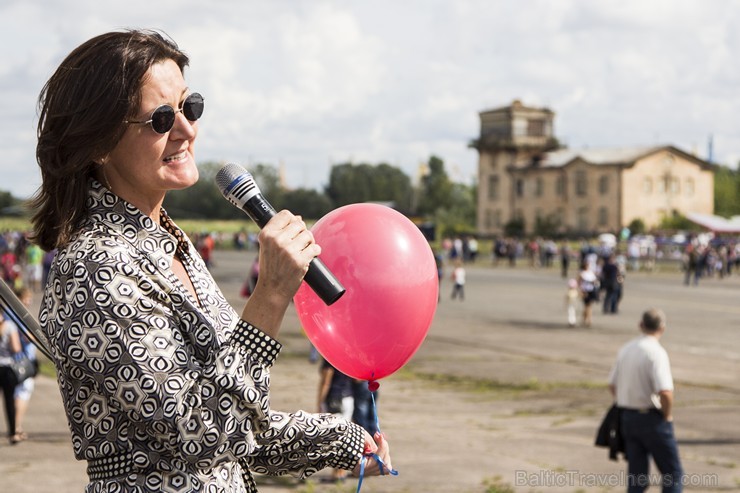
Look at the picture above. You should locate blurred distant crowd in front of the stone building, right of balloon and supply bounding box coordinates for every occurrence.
[435,235,740,327]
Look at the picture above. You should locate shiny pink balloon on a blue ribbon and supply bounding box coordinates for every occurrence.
[294,204,439,380]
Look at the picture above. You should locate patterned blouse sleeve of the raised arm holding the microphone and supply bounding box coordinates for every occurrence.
[41,246,286,469]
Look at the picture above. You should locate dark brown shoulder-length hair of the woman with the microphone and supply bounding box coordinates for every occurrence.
[30,29,189,251]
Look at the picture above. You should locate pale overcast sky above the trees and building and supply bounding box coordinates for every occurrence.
[0,0,740,197]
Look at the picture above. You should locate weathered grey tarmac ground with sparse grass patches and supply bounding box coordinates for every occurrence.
[0,252,740,493]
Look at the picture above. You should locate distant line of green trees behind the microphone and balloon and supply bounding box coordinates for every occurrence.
[0,156,476,233]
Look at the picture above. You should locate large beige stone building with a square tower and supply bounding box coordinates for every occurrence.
[471,101,714,236]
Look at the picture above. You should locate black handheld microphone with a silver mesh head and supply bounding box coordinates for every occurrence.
[216,164,346,306]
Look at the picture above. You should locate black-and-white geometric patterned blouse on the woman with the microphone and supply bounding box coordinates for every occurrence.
[39,180,364,493]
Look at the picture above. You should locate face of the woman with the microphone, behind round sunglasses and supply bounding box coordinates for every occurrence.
[102,60,198,215]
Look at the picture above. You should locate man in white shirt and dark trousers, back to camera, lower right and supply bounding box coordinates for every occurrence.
[609,309,683,493]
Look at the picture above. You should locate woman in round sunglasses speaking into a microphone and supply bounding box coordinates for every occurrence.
[34,31,390,492]
